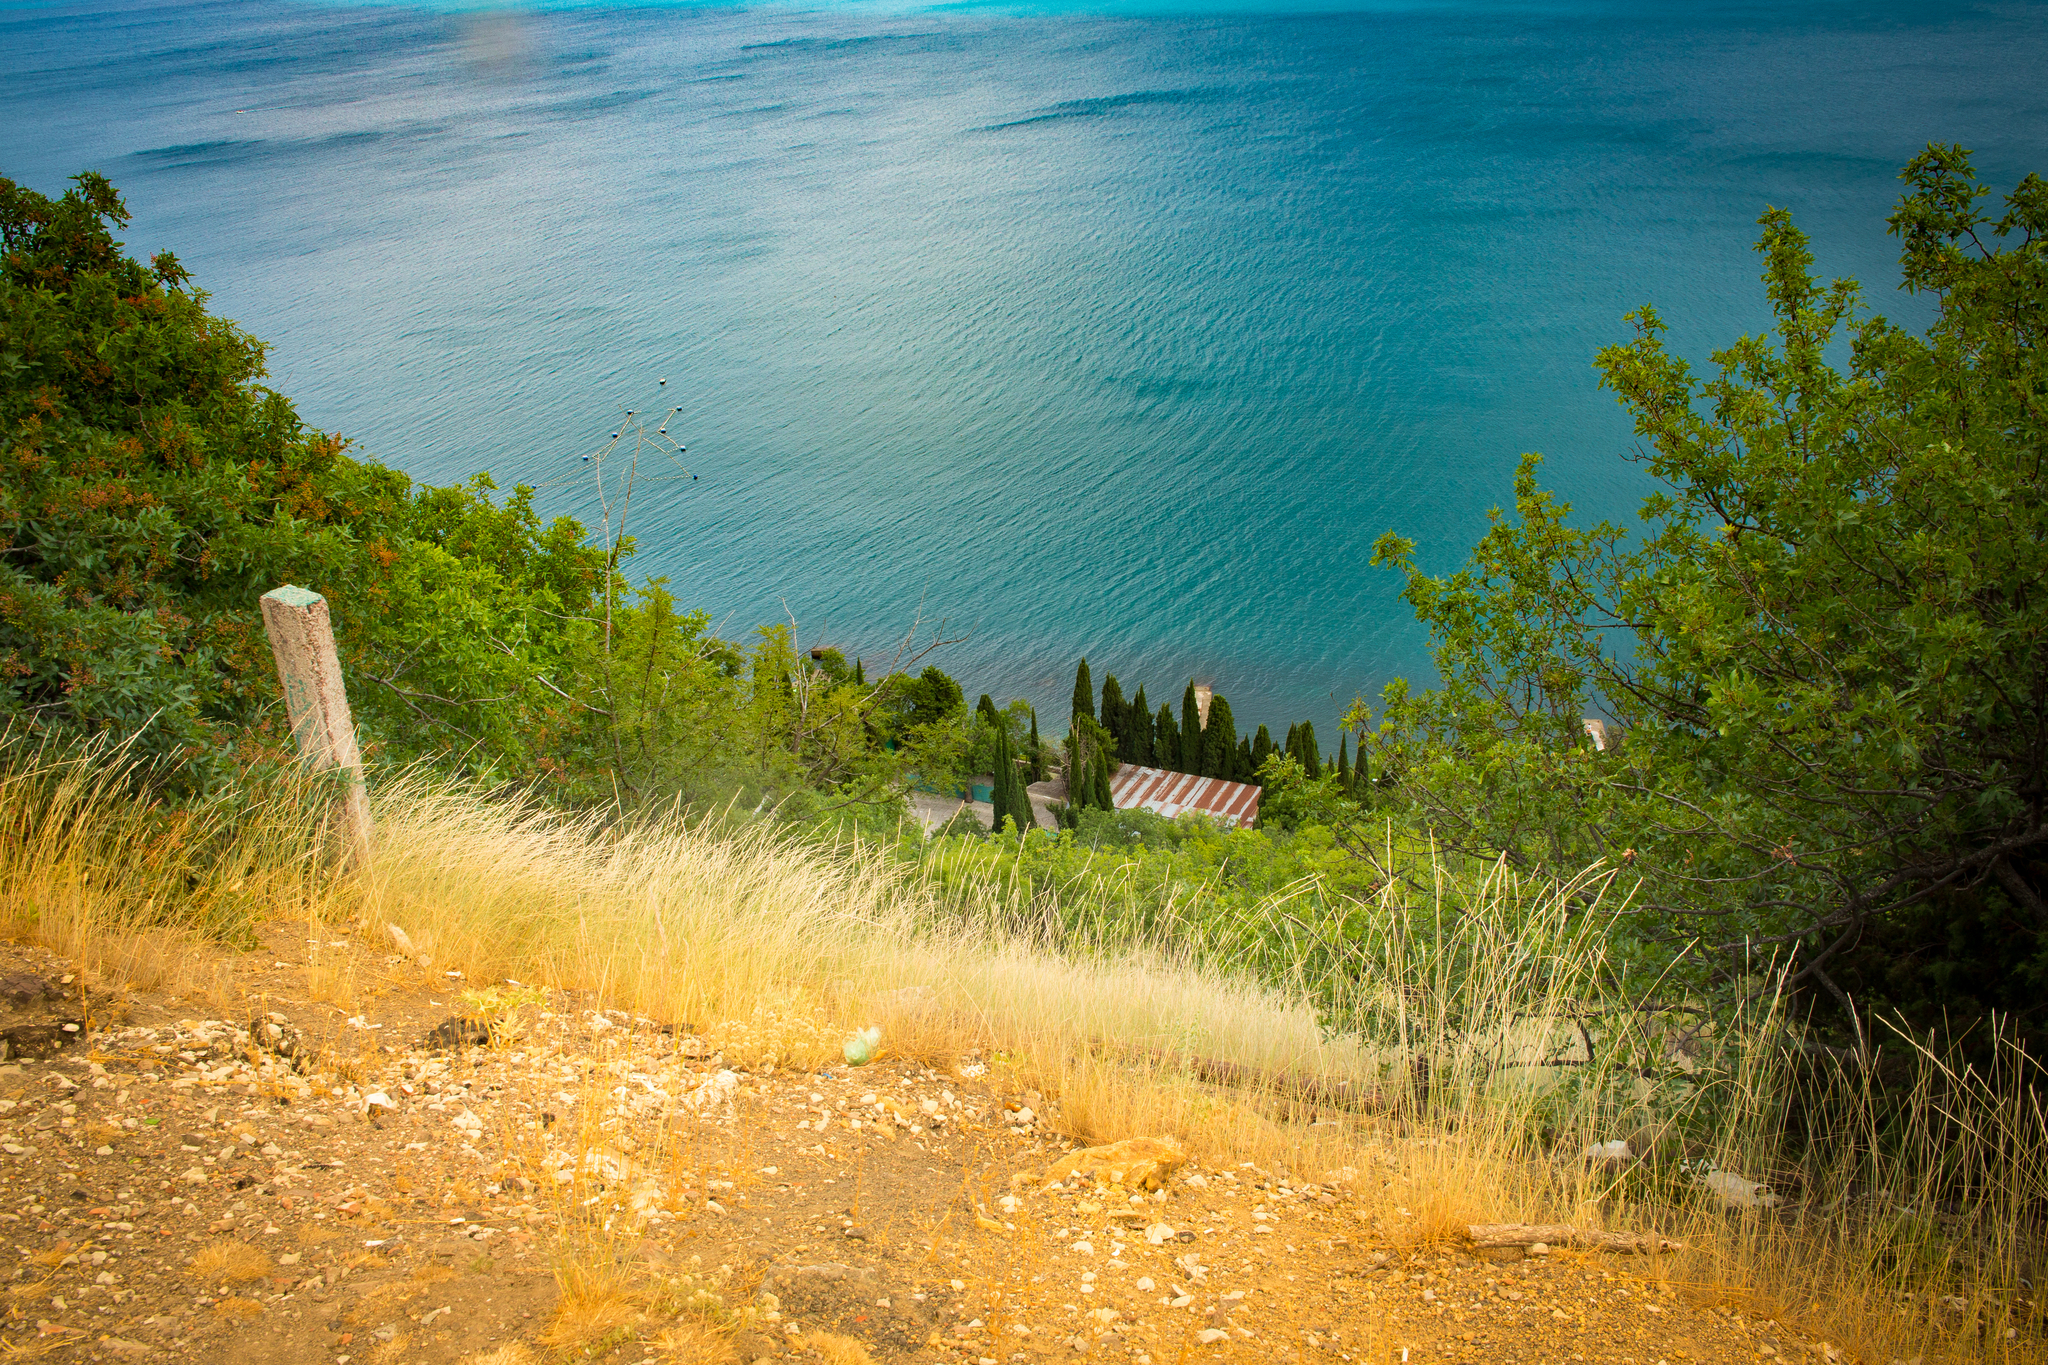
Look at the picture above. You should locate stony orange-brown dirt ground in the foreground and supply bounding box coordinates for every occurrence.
[0,927,1839,1365]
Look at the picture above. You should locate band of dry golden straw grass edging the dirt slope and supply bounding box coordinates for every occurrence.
[0,753,2048,1363]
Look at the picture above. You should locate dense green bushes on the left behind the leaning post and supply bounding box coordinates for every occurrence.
[0,174,608,784]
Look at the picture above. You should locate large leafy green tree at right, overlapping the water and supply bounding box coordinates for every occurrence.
[1358,145,2048,1038]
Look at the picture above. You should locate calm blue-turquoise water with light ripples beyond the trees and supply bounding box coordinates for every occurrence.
[0,0,2048,733]
